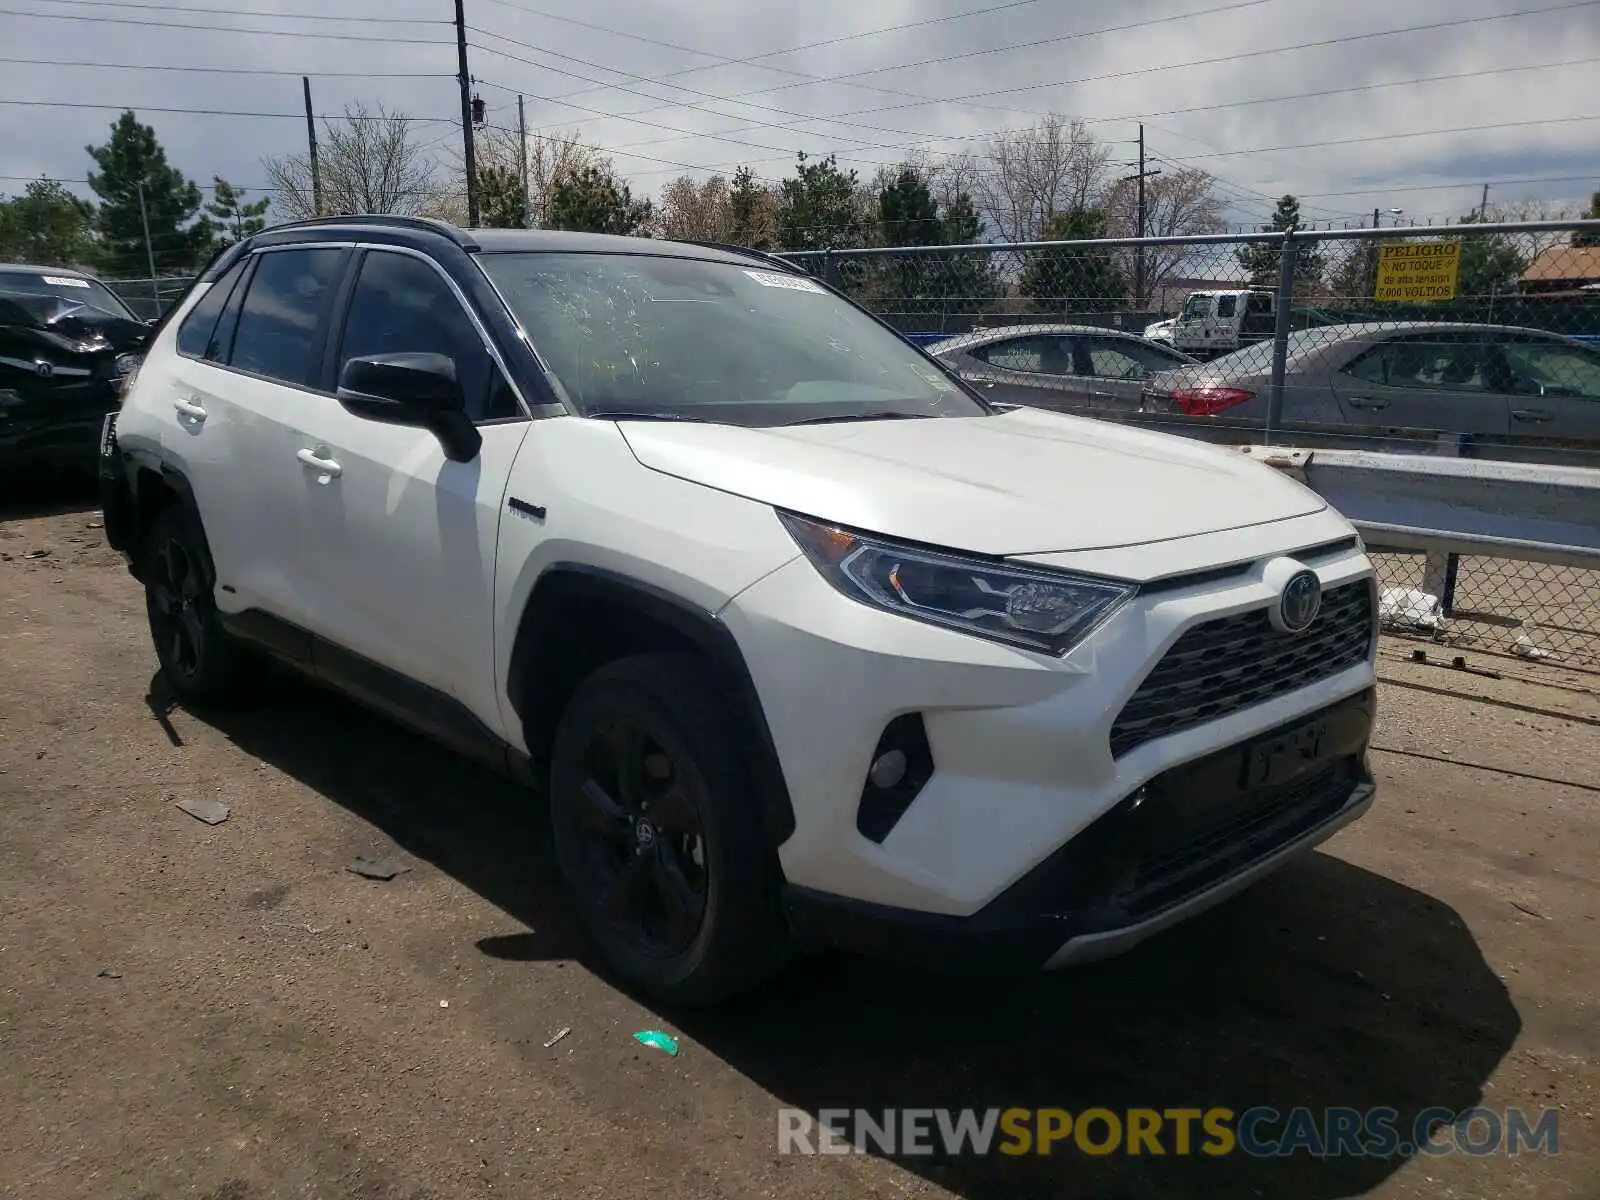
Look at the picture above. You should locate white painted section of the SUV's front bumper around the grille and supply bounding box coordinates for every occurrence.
[720,514,1376,918]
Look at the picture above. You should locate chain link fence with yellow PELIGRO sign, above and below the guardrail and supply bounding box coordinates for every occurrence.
[786,221,1600,669]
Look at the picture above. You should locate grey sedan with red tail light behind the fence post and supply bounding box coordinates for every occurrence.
[1142,322,1600,438]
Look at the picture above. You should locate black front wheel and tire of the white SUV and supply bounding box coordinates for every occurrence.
[550,654,789,1005]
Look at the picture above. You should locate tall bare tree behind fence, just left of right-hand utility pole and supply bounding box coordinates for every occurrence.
[973,115,1110,242]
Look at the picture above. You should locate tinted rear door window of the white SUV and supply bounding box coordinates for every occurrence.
[229,248,344,387]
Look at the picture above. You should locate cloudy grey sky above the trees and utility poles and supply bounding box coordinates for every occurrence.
[0,0,1600,230]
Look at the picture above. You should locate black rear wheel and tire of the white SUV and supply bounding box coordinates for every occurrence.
[141,504,261,707]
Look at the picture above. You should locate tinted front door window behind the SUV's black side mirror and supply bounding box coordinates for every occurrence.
[339,250,522,421]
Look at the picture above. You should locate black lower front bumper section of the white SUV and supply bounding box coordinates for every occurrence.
[786,691,1374,970]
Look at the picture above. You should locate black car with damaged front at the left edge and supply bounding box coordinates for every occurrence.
[0,264,150,475]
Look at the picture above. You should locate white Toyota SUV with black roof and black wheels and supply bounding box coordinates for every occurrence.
[101,218,1376,1002]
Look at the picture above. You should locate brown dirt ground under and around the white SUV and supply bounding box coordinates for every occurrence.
[0,492,1600,1200]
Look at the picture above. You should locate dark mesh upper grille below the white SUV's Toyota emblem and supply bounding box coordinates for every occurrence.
[1110,579,1373,758]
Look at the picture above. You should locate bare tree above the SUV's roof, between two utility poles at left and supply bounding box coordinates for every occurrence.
[262,102,438,219]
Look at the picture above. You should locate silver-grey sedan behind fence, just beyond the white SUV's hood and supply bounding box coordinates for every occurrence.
[926,325,1195,413]
